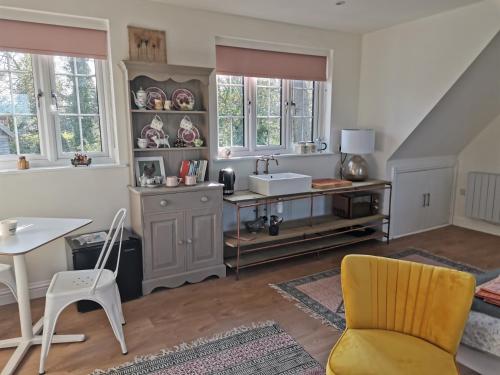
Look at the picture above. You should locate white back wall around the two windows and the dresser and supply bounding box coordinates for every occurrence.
[0,0,361,302]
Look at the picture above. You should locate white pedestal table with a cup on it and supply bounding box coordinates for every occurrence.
[0,217,92,375]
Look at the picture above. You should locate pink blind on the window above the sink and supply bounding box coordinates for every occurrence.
[216,45,326,81]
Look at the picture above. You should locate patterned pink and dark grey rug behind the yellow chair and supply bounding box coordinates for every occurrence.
[271,248,484,331]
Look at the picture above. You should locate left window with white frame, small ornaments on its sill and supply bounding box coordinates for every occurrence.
[0,52,111,168]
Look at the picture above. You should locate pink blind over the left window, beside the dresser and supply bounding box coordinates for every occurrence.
[0,19,108,59]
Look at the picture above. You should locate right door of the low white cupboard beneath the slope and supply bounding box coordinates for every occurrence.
[425,168,453,228]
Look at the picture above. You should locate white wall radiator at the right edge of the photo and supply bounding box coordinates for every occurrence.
[465,172,500,224]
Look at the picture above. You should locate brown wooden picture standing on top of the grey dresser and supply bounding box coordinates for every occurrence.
[128,26,167,63]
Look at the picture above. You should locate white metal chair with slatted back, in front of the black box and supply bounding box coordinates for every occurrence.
[39,208,127,374]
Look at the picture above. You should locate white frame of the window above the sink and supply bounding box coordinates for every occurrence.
[214,76,325,157]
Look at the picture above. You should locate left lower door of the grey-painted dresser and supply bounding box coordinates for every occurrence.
[144,212,186,278]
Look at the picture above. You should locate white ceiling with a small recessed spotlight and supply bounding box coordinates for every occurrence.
[151,0,480,33]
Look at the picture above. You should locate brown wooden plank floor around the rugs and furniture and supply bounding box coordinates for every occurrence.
[0,226,500,375]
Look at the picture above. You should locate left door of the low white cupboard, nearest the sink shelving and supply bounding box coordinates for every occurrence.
[391,171,427,236]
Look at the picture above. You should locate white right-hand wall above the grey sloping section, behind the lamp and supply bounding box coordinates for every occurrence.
[358,2,500,177]
